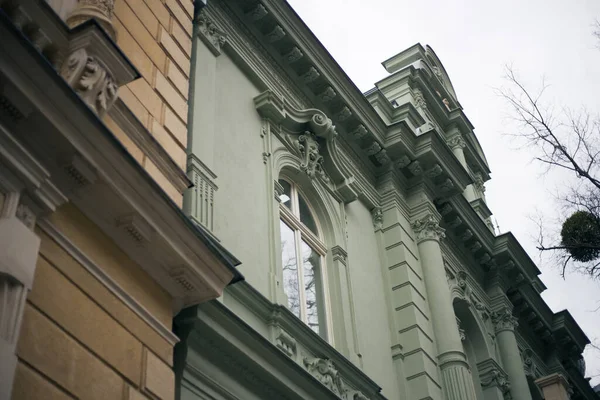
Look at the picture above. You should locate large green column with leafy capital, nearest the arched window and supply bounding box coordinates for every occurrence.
[412,214,476,400]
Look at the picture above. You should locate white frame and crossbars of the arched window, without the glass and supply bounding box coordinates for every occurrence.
[278,180,333,344]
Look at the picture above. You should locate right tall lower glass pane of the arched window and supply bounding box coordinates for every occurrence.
[302,241,321,333]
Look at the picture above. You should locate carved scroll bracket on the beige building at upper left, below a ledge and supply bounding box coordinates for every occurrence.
[61,49,118,116]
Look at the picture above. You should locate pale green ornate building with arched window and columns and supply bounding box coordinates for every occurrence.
[175,0,597,400]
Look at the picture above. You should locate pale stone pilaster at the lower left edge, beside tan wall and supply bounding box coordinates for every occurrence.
[0,192,40,400]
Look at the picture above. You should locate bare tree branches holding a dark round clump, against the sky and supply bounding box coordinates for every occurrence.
[498,65,600,278]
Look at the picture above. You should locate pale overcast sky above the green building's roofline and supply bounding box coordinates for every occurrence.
[289,0,600,383]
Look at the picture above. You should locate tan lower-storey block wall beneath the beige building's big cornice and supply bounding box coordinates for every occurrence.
[13,205,175,399]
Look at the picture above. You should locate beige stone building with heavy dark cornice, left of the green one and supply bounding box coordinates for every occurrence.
[0,0,241,400]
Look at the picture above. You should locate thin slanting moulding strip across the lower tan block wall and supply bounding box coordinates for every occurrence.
[38,219,179,346]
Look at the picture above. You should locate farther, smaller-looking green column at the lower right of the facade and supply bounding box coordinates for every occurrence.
[492,307,532,400]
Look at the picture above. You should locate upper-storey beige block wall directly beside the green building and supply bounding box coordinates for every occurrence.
[105,0,194,204]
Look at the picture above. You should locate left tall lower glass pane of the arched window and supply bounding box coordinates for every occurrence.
[279,221,300,318]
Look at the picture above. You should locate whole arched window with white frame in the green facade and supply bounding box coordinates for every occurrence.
[279,179,327,338]
